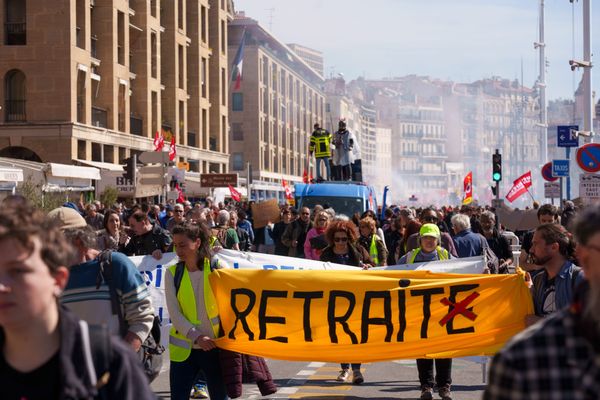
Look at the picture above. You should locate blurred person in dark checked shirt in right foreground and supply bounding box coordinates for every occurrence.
[483,205,600,400]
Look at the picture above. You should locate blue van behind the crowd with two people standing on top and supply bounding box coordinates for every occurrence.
[294,181,377,218]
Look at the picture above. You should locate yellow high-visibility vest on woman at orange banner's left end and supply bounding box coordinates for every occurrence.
[168,258,221,362]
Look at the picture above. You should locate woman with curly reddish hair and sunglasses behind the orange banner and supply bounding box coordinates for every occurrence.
[321,221,375,385]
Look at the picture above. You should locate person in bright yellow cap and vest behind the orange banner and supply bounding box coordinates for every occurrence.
[398,224,452,400]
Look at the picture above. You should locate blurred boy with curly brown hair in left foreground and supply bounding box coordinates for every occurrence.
[0,205,156,400]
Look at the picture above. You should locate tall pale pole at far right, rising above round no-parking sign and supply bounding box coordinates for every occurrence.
[583,0,594,141]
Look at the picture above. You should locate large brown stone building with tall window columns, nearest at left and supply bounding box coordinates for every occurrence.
[0,0,233,187]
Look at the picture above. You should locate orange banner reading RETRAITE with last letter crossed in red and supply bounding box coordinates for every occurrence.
[210,269,533,362]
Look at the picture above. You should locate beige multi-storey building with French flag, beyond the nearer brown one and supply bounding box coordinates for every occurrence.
[229,13,325,200]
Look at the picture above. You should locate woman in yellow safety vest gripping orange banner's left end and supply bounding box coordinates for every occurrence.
[165,223,228,400]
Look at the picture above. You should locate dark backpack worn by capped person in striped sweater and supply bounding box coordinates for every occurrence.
[96,250,165,382]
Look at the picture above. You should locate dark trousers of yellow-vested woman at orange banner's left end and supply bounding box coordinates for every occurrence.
[169,349,229,400]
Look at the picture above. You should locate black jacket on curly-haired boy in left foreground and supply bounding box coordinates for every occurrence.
[0,306,156,400]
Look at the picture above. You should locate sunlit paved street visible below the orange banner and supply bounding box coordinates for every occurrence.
[152,359,484,400]
